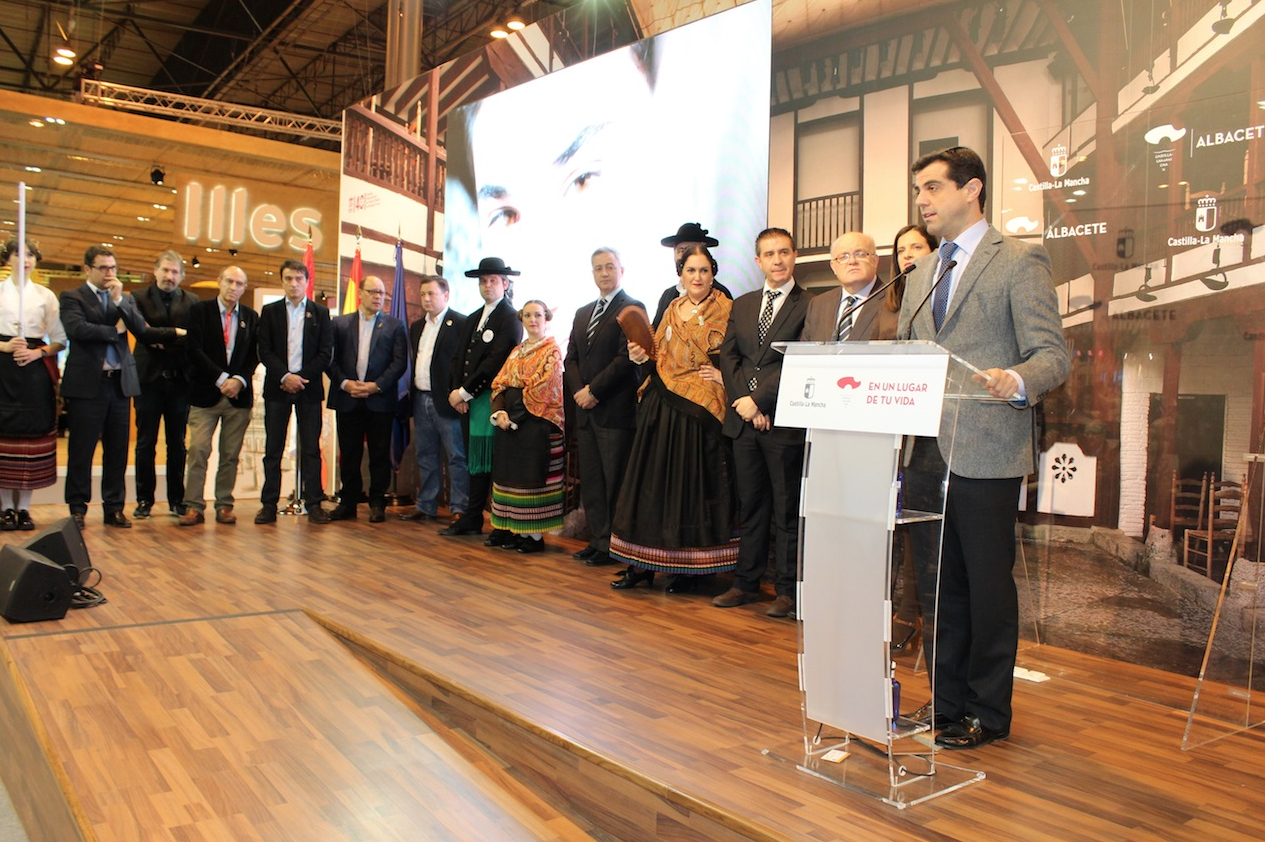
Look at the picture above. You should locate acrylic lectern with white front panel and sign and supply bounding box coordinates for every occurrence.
[765,341,999,808]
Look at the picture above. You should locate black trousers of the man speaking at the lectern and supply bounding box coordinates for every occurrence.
[906,439,1022,731]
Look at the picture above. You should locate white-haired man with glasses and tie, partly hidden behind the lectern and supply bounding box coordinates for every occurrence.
[799,231,899,343]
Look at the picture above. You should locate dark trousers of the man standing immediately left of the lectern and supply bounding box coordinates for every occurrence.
[734,424,803,599]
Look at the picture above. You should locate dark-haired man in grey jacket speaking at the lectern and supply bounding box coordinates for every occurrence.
[899,147,1070,748]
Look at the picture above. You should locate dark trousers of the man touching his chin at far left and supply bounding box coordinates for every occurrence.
[66,372,132,515]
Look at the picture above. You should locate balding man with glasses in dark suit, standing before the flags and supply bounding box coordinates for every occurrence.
[329,274,409,523]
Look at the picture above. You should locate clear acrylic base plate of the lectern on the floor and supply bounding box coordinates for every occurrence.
[760,738,984,810]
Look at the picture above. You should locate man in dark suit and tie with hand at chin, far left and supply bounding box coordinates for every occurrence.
[61,245,185,528]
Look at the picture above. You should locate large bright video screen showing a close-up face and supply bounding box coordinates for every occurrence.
[444,0,770,333]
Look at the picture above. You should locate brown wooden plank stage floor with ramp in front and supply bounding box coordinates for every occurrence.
[0,503,1265,842]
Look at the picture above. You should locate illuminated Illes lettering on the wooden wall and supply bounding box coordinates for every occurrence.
[183,181,323,252]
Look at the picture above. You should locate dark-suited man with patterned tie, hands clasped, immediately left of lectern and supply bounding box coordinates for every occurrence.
[712,228,808,617]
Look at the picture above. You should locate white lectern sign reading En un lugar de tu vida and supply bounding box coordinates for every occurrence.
[777,354,949,436]
